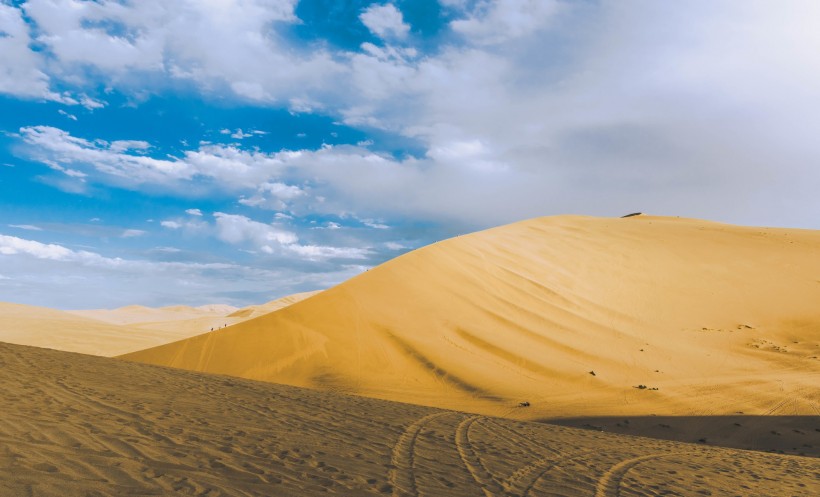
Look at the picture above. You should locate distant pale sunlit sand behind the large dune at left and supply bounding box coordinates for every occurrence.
[0,292,318,357]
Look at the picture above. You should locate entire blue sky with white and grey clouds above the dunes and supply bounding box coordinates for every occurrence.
[0,0,820,309]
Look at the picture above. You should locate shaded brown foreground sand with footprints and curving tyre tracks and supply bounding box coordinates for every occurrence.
[0,344,820,497]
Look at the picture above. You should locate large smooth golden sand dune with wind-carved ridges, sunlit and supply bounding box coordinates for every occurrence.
[120,216,820,446]
